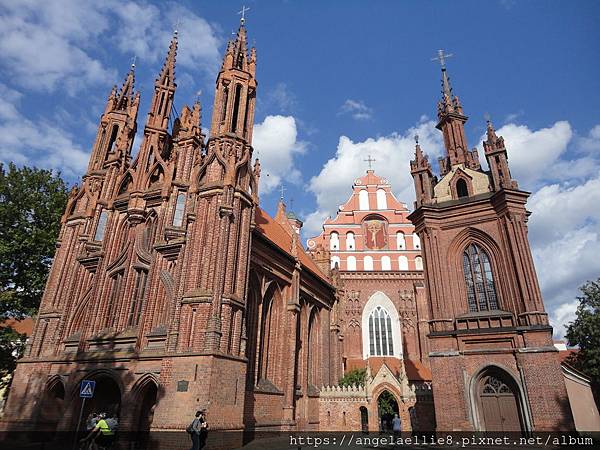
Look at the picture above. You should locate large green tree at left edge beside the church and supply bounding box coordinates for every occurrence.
[0,163,68,384]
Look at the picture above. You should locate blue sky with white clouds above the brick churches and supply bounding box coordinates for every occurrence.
[0,0,600,335]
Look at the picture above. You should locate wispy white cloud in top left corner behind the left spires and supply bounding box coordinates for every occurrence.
[0,0,219,94]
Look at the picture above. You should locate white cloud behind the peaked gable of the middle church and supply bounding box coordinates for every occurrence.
[304,118,442,236]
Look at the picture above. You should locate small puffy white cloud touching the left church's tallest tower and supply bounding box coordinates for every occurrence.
[252,116,306,194]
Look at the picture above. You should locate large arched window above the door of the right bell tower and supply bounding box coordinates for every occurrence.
[463,244,498,312]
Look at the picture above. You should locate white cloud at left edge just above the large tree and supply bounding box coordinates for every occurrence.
[0,83,89,178]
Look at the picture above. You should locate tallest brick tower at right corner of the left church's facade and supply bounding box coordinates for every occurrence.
[161,14,260,429]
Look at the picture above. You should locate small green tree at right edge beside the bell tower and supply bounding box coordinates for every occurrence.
[566,278,600,398]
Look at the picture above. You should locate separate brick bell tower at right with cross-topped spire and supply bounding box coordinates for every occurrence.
[409,51,572,432]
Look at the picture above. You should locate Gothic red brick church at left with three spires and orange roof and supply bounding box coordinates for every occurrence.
[3,24,341,442]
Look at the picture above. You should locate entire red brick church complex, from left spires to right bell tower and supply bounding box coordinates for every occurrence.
[3,16,573,442]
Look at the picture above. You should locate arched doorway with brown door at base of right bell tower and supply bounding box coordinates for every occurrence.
[474,367,525,432]
